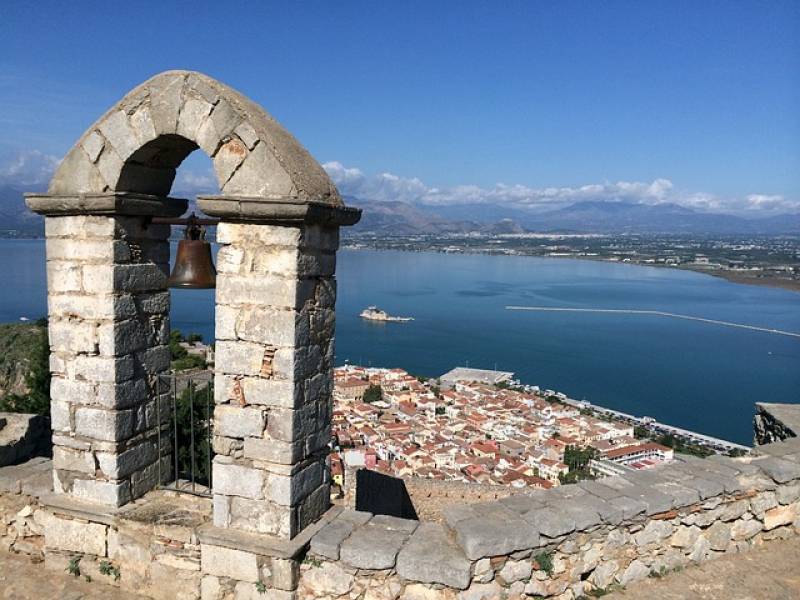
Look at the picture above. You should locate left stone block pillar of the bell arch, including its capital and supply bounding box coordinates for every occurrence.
[28,194,185,506]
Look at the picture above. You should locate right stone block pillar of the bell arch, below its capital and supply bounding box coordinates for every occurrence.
[213,223,339,538]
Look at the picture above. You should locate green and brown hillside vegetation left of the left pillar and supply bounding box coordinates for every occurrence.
[0,320,50,415]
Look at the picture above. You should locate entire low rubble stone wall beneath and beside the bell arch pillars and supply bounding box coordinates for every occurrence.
[0,438,800,600]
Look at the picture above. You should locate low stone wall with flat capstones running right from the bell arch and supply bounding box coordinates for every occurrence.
[298,440,800,600]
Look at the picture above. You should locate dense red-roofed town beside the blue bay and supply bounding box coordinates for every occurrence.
[331,365,674,489]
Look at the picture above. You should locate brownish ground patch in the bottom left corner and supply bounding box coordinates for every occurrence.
[0,552,145,600]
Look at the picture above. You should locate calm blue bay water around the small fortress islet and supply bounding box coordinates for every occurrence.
[0,240,800,443]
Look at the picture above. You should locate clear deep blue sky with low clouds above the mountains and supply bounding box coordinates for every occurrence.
[0,0,800,214]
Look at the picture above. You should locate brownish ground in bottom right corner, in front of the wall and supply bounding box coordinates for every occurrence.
[607,538,800,600]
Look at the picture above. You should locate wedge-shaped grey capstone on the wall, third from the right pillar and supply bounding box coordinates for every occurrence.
[396,523,471,590]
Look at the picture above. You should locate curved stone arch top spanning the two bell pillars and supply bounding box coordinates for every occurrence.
[48,71,343,207]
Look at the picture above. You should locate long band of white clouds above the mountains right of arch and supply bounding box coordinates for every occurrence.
[322,161,800,215]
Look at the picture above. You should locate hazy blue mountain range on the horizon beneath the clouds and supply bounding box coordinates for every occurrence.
[0,185,800,237]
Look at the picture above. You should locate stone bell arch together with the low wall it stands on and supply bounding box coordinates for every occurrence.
[0,71,800,600]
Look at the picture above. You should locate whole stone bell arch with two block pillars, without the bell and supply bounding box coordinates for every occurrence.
[27,71,360,539]
